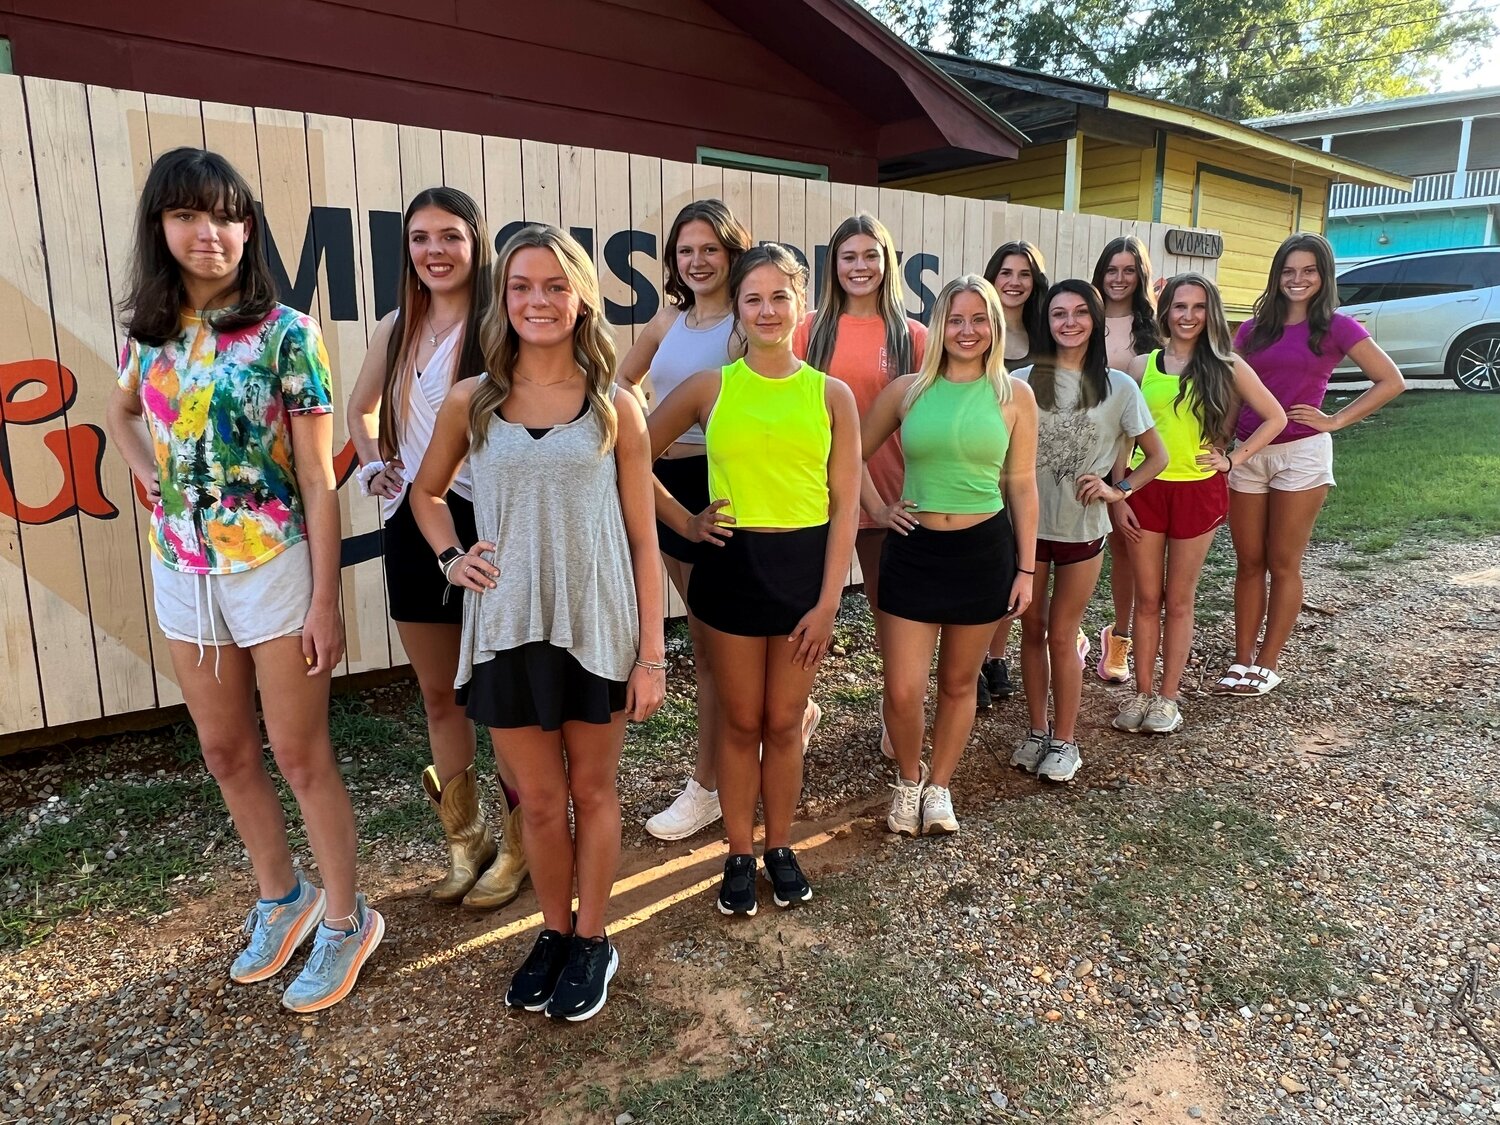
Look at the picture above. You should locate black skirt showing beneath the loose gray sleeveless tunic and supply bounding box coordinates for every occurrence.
[456,641,626,731]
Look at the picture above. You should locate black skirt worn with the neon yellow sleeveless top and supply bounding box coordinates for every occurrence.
[687,524,828,636]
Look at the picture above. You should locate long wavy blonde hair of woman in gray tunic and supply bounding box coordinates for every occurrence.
[470,224,620,456]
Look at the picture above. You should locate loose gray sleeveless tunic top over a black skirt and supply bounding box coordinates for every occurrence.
[455,408,639,687]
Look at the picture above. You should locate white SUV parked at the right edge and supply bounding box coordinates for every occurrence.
[1337,246,1500,392]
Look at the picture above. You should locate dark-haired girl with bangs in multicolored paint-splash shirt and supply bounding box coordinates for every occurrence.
[107,149,386,1013]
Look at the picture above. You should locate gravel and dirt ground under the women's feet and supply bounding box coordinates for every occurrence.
[0,540,1500,1125]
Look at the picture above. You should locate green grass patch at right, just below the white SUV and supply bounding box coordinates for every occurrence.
[1314,392,1500,554]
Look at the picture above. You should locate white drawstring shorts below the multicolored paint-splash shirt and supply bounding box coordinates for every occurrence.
[152,540,312,650]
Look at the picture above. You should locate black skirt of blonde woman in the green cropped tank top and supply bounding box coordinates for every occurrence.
[881,512,1016,626]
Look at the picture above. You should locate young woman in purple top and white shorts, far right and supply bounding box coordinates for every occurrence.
[1214,234,1406,696]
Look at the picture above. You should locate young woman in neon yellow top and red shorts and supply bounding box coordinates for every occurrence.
[1115,273,1287,735]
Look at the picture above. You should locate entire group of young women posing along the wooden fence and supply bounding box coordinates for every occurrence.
[108,149,1401,1020]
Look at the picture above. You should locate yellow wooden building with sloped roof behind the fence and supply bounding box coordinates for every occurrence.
[882,53,1410,320]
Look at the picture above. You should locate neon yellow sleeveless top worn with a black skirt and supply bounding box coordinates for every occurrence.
[704,359,834,528]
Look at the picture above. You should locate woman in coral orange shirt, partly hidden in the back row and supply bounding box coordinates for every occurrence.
[792,212,927,633]
